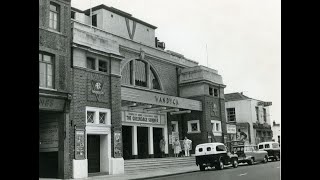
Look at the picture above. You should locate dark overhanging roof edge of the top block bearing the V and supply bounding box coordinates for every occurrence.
[83,4,157,29]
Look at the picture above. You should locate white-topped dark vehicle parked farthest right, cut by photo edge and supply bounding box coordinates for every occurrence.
[258,142,280,161]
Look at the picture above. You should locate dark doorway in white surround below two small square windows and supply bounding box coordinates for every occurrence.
[87,135,100,173]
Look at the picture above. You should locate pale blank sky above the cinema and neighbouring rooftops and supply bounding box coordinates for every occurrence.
[71,0,281,123]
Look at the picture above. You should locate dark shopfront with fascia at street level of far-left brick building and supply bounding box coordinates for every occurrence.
[39,93,69,178]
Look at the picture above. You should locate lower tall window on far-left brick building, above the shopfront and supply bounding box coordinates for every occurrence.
[39,53,54,89]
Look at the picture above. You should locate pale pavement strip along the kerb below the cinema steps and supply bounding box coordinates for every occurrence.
[39,165,199,180]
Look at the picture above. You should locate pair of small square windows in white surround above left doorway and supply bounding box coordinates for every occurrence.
[86,107,111,125]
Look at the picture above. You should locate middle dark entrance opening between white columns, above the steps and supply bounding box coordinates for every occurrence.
[137,127,149,159]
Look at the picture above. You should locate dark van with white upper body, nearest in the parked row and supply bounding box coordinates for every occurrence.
[195,143,238,171]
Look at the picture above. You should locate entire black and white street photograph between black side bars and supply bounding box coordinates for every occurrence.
[36,0,285,180]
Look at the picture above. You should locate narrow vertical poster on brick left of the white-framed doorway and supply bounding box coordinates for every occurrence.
[74,129,85,159]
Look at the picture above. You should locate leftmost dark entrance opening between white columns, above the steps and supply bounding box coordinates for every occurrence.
[122,126,132,159]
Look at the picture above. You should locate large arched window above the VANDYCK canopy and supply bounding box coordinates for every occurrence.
[121,59,161,90]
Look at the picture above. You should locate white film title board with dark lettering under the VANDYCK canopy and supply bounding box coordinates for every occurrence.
[125,111,160,124]
